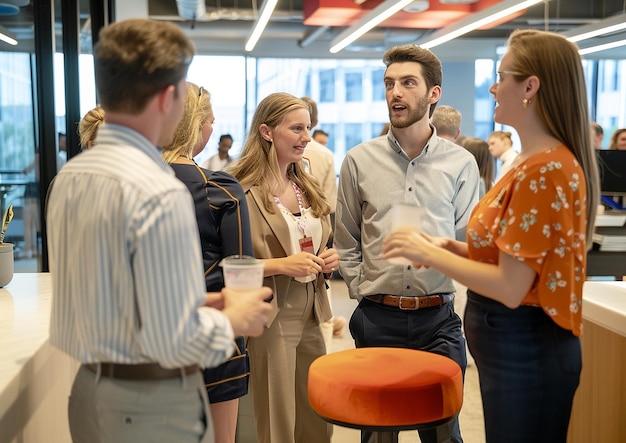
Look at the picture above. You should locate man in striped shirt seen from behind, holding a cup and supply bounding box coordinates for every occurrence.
[46,19,272,443]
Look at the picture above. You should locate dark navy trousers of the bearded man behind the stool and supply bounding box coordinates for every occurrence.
[350,299,467,443]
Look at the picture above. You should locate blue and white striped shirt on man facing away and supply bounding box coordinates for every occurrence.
[47,124,234,368]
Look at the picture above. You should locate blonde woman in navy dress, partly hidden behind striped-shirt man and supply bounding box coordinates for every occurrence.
[161,82,254,443]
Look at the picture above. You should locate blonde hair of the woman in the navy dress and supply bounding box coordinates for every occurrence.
[161,82,213,163]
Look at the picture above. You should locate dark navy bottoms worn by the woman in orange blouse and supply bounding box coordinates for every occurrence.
[464,291,582,443]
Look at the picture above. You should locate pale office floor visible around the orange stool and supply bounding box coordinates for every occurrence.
[331,279,485,443]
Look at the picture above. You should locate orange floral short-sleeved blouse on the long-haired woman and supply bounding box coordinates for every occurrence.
[467,146,587,336]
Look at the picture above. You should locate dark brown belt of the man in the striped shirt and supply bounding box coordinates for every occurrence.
[85,363,200,381]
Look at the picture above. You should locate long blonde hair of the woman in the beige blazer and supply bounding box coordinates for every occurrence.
[226,92,330,217]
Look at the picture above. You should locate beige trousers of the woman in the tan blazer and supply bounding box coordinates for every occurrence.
[248,280,332,443]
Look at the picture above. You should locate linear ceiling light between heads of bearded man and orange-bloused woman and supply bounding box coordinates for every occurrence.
[415,0,544,49]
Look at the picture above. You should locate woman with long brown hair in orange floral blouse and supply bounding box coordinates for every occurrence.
[384,30,599,443]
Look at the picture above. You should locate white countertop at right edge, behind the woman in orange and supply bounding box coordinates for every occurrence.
[583,281,626,337]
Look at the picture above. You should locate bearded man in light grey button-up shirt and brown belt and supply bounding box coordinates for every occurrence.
[334,45,480,443]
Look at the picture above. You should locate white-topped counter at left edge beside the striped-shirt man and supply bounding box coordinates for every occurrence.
[0,273,78,443]
